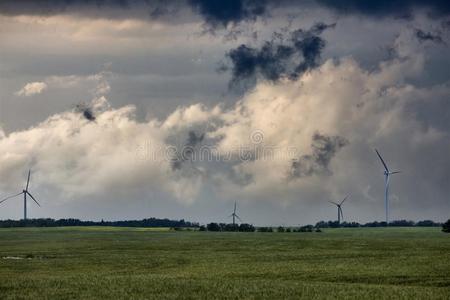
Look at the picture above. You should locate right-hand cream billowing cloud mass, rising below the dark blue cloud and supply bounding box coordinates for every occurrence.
[202,32,450,211]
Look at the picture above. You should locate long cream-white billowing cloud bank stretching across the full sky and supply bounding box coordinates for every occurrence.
[0,32,450,216]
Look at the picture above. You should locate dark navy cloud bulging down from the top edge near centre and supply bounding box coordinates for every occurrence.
[189,0,267,30]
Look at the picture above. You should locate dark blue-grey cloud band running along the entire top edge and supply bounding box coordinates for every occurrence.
[0,0,450,21]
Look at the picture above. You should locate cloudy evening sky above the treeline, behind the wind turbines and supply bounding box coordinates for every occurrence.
[0,0,450,225]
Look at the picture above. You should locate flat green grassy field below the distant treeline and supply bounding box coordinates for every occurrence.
[0,227,450,299]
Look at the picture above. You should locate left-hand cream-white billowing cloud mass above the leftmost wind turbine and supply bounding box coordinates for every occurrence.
[0,96,200,202]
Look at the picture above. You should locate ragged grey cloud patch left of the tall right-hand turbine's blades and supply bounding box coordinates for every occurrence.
[290,133,349,179]
